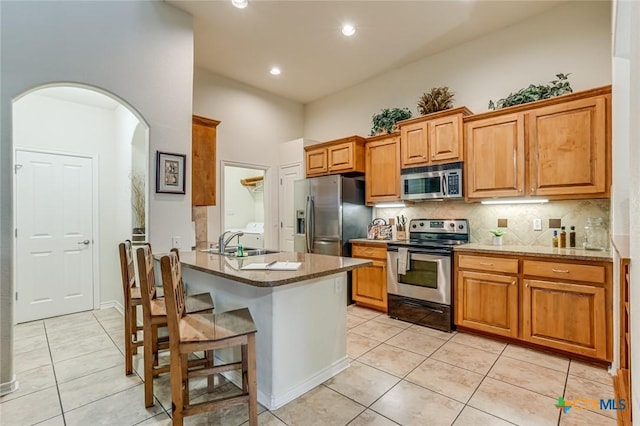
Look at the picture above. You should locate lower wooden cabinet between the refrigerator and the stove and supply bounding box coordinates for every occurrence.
[351,243,387,312]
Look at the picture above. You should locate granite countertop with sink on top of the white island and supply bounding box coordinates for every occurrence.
[164,251,373,287]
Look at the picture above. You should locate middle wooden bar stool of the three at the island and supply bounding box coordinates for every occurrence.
[136,244,214,407]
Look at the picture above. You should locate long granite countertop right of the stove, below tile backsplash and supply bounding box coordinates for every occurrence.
[454,243,613,262]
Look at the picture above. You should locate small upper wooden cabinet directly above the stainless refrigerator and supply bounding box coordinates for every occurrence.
[304,136,365,177]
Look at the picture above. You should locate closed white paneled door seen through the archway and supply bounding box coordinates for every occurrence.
[15,150,94,322]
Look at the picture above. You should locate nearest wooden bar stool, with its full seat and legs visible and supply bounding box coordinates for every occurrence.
[160,253,258,426]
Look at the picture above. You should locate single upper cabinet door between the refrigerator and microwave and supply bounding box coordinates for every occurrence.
[365,136,400,204]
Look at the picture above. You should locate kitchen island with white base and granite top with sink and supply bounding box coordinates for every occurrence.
[171,252,371,410]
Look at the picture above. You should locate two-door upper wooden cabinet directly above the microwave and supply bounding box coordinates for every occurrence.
[397,107,471,168]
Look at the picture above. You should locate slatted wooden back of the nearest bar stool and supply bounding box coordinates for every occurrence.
[160,252,185,340]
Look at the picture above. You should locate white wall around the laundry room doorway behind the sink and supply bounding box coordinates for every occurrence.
[193,68,303,247]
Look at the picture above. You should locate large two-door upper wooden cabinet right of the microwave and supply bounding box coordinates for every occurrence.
[464,86,611,200]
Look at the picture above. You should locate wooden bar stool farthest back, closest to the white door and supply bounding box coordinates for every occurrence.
[118,240,143,375]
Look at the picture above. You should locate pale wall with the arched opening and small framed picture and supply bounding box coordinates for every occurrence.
[0,1,193,392]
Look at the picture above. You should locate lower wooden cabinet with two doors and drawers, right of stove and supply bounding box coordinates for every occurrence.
[454,252,613,361]
